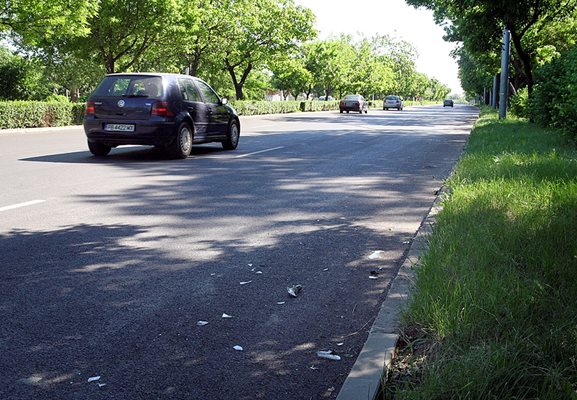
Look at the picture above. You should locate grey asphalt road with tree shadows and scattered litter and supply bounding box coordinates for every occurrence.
[0,106,477,400]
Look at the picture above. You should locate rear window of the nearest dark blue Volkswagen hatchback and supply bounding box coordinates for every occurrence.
[94,75,162,98]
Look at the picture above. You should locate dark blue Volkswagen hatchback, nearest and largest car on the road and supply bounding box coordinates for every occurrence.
[84,73,240,158]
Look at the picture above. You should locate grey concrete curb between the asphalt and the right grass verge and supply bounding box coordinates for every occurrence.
[337,196,442,400]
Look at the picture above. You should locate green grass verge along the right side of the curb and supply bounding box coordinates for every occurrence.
[385,110,577,400]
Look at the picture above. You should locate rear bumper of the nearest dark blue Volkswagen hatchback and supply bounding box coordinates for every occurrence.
[84,119,176,147]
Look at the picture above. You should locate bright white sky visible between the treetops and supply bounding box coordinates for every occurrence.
[295,0,463,94]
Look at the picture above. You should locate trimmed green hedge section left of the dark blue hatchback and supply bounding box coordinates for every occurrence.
[0,101,85,129]
